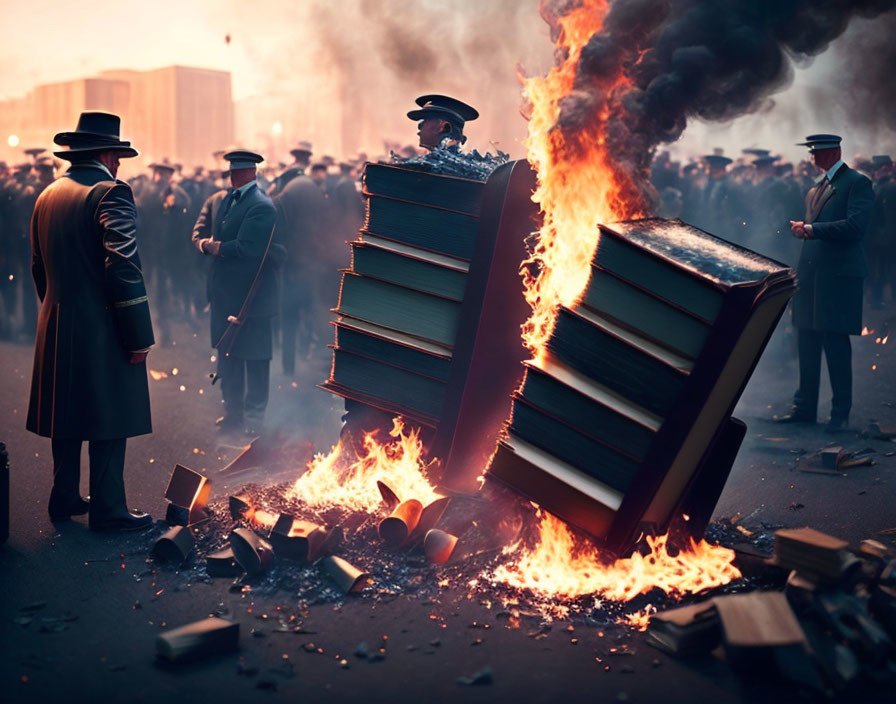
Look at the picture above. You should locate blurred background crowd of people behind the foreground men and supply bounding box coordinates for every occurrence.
[0,142,896,358]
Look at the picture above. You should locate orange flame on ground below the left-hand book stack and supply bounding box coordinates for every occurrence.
[288,417,441,513]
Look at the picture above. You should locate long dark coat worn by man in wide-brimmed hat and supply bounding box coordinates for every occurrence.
[27,165,154,440]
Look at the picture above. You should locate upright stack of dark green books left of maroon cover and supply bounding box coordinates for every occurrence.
[322,163,485,427]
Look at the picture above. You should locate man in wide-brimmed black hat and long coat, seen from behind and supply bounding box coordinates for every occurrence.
[27,112,154,530]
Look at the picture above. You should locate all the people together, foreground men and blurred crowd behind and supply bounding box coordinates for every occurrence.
[0,95,896,530]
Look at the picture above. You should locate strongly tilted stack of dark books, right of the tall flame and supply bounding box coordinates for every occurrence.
[490,219,795,552]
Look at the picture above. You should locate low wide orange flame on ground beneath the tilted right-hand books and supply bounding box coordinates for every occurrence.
[492,512,741,601]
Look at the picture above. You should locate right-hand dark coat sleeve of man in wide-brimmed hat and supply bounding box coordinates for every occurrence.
[97,182,155,352]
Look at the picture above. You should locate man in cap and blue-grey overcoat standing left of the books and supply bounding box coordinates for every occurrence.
[193,150,285,434]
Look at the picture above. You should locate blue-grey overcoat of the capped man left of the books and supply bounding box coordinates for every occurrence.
[199,185,283,359]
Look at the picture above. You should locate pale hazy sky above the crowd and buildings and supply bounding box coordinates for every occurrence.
[0,0,896,158]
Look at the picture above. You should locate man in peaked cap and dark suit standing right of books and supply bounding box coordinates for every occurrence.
[778,134,874,433]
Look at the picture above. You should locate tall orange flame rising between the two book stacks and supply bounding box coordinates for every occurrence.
[520,0,642,361]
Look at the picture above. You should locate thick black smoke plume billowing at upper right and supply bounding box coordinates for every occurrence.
[542,0,896,208]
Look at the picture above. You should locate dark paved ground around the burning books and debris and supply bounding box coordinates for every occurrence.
[0,312,896,703]
